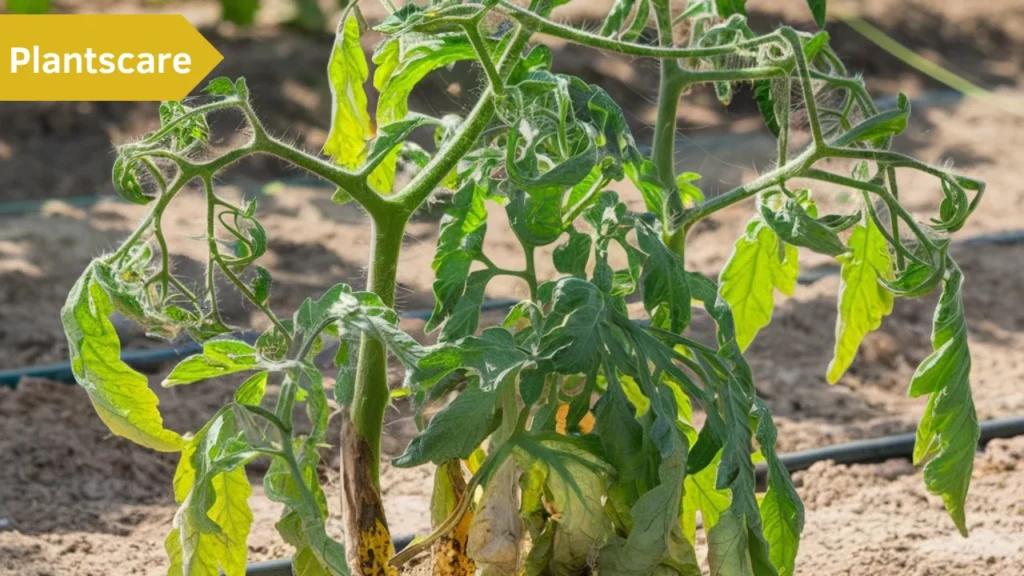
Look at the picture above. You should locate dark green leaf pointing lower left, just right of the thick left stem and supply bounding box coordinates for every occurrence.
[391,381,500,468]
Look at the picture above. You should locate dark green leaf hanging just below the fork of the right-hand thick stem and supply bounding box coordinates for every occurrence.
[636,223,691,334]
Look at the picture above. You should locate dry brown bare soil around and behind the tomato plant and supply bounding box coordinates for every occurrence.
[0,0,1024,576]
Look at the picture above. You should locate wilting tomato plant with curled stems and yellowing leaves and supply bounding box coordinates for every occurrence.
[62,0,984,575]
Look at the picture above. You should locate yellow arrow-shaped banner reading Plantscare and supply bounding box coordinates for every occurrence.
[0,14,223,101]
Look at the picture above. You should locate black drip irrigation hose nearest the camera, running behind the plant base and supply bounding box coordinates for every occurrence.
[234,416,1024,576]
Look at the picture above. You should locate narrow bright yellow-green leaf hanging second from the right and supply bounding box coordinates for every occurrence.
[827,218,893,383]
